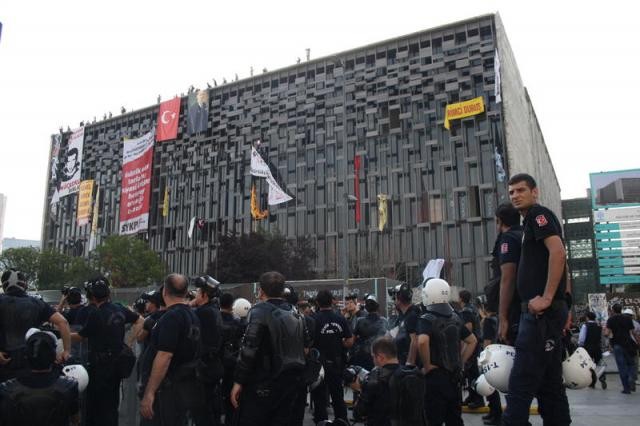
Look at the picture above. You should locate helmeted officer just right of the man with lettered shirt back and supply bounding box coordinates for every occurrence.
[350,294,388,371]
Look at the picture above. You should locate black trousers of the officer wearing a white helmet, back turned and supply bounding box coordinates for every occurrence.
[425,368,464,426]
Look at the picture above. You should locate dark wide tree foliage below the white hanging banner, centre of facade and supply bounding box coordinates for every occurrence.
[207,232,316,283]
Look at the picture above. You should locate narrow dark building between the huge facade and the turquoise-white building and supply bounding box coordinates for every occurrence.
[562,196,606,303]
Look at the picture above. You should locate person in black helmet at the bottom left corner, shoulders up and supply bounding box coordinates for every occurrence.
[0,331,80,426]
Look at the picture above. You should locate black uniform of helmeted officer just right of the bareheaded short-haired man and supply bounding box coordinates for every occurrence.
[194,302,224,426]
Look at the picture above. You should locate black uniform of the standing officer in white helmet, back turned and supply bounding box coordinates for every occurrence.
[418,303,471,426]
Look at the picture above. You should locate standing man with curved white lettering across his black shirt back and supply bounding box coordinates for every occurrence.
[311,290,354,423]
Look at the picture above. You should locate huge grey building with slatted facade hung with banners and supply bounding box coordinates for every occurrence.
[42,15,560,291]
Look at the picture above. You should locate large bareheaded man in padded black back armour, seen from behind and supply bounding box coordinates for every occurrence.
[231,271,311,426]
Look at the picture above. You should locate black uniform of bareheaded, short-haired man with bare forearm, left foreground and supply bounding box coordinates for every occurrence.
[142,303,205,425]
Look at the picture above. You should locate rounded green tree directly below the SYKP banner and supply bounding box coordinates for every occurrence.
[92,235,167,287]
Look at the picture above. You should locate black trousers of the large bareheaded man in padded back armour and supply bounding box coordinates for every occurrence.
[237,371,302,426]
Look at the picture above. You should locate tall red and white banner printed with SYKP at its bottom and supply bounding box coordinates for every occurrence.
[120,132,154,235]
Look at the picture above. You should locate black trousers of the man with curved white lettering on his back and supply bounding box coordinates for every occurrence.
[311,363,347,423]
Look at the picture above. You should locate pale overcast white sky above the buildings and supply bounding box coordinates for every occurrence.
[0,0,640,239]
